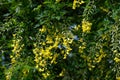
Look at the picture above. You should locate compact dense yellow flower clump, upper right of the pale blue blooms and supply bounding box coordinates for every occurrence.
[82,20,92,33]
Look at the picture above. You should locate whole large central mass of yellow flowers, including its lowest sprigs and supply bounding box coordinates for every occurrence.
[33,26,74,79]
